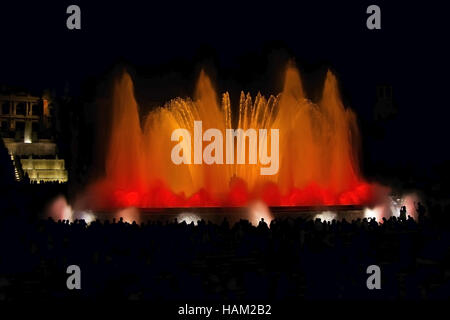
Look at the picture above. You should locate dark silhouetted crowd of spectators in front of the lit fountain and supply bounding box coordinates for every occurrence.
[0,207,450,301]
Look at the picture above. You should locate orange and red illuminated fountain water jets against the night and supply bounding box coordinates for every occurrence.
[89,66,373,208]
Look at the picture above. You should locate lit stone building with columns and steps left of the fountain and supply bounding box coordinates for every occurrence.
[0,94,67,183]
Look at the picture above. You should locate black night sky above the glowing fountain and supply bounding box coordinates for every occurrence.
[0,0,450,175]
